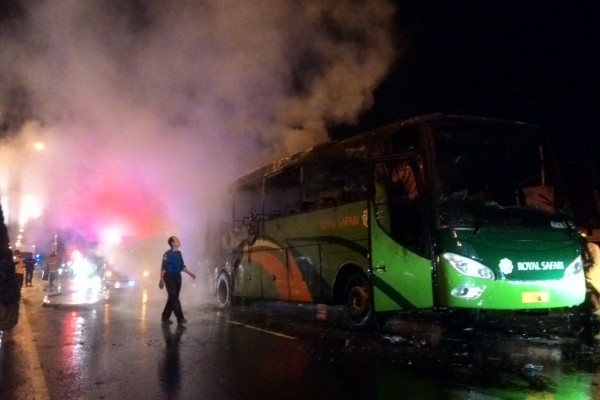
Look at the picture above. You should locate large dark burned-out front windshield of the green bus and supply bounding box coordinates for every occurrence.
[434,126,568,228]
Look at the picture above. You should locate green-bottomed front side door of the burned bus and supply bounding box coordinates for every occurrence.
[369,158,433,312]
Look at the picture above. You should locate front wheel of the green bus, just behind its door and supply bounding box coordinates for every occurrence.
[344,273,373,329]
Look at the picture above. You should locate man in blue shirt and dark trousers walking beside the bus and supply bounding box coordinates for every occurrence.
[158,236,196,324]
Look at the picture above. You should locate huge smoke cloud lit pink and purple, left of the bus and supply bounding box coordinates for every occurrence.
[0,0,397,272]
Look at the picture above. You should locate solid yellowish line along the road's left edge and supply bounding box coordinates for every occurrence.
[16,294,50,400]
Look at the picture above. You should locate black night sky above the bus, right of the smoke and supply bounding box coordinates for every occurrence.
[336,1,600,151]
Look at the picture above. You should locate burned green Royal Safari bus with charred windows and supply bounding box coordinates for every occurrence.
[212,114,586,327]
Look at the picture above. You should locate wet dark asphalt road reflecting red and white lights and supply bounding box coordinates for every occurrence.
[0,272,600,399]
